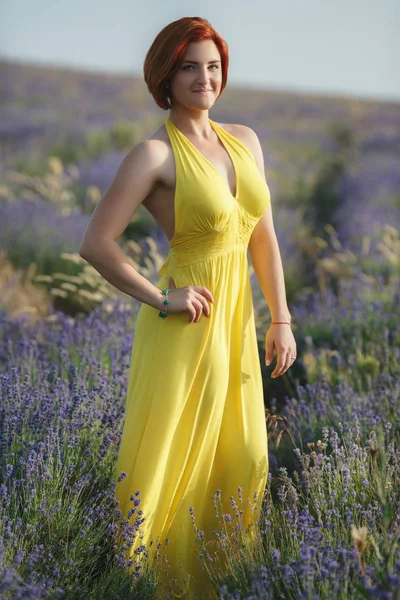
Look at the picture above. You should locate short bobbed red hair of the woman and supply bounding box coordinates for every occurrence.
[143,17,229,110]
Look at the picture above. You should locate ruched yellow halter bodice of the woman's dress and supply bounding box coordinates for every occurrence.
[158,117,270,276]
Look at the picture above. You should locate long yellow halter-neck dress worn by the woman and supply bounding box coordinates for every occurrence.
[115,116,271,600]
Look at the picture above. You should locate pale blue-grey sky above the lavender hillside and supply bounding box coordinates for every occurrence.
[0,0,400,101]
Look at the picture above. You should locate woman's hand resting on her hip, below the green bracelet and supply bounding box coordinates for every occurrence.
[168,275,214,323]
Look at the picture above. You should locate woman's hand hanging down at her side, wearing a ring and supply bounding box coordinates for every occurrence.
[265,323,297,378]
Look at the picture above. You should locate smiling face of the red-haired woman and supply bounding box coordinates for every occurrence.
[169,40,222,109]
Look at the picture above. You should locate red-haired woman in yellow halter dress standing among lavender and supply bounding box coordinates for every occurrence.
[80,17,296,599]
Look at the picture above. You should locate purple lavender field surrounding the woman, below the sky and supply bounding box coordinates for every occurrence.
[0,63,400,600]
